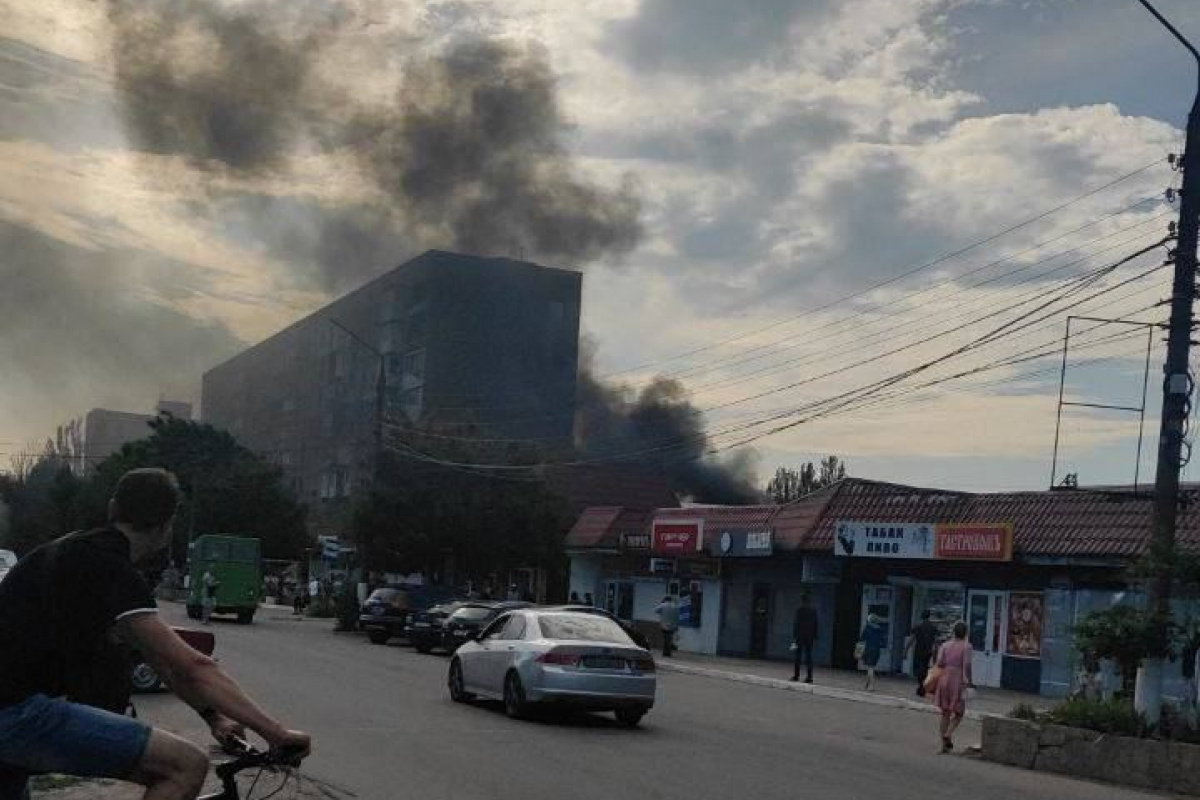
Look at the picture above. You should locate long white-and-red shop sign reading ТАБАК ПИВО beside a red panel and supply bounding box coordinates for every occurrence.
[833,521,1013,561]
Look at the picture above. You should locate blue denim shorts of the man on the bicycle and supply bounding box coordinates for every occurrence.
[0,694,150,800]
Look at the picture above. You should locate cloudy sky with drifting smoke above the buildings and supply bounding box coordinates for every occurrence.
[0,0,1200,491]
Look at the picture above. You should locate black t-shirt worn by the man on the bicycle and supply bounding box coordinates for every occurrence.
[0,528,157,706]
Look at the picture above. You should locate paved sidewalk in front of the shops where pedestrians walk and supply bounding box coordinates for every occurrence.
[654,651,1050,720]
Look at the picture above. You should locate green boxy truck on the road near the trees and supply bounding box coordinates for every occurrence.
[187,534,263,625]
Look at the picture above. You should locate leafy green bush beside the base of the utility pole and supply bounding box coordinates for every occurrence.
[1075,606,1177,685]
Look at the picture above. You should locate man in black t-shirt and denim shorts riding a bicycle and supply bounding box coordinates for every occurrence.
[0,469,311,800]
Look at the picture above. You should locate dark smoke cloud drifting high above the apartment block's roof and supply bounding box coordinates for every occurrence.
[109,0,642,289]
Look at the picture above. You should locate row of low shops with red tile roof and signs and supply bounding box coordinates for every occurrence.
[568,479,1200,696]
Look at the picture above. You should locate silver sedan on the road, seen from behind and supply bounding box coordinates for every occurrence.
[449,609,656,727]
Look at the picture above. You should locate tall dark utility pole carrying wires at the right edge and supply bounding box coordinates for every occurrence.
[1134,0,1200,723]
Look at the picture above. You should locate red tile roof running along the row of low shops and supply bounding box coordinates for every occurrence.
[566,479,1200,558]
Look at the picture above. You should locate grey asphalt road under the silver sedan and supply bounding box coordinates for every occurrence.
[124,604,1157,800]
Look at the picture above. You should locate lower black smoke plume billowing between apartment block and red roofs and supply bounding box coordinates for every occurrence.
[575,355,763,504]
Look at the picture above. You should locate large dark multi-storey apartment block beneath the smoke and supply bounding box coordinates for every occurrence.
[202,251,582,533]
